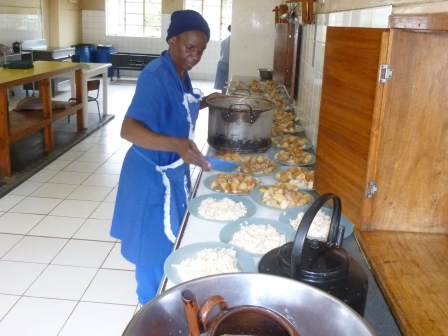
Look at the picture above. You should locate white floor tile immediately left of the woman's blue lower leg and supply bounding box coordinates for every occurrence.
[81,269,137,305]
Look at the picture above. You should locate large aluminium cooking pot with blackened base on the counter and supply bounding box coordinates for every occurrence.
[207,96,275,153]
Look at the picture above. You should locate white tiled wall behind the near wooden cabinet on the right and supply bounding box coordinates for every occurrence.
[296,6,392,146]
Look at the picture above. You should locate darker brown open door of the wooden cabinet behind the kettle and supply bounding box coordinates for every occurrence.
[314,27,388,229]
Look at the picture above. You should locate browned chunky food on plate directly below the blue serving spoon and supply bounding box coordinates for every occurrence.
[210,173,260,194]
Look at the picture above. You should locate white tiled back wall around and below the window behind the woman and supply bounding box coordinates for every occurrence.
[82,10,221,80]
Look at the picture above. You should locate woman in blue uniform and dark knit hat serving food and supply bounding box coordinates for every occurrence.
[111,10,221,305]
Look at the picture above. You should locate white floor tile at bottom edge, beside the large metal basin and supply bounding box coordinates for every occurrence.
[58,302,135,336]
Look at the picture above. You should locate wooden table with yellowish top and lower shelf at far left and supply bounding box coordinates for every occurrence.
[0,61,84,177]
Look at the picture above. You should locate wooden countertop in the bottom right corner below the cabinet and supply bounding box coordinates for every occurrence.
[355,230,448,335]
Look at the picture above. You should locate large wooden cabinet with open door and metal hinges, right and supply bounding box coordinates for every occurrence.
[315,27,448,234]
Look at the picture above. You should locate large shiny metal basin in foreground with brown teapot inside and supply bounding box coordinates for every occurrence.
[123,273,375,336]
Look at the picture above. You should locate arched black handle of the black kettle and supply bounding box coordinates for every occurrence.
[291,193,342,279]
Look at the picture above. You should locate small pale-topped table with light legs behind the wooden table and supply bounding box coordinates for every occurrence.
[70,63,112,127]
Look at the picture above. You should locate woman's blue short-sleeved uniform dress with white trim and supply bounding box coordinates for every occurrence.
[111,51,203,304]
